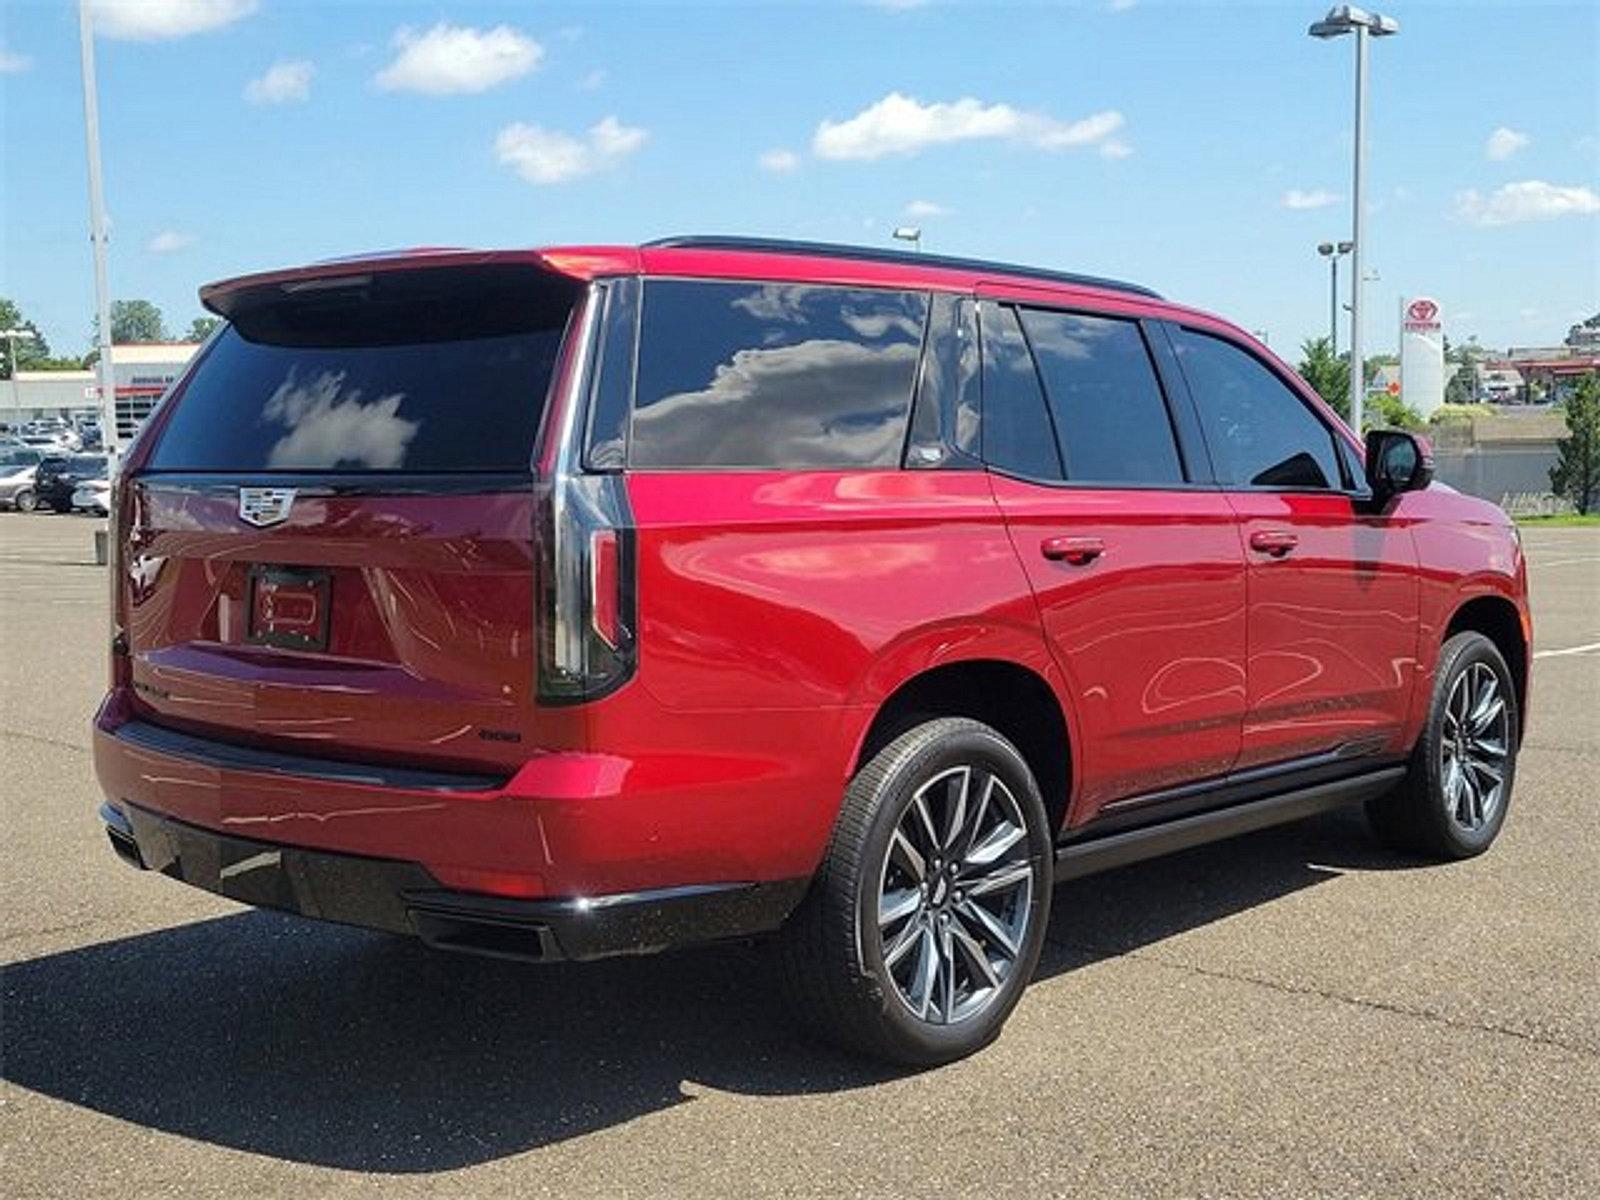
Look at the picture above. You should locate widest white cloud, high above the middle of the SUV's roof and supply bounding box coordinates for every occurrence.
[811,91,1123,160]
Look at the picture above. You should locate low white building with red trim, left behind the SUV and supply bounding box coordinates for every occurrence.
[0,342,200,442]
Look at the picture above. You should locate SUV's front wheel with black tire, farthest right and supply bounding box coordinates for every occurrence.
[1366,632,1522,861]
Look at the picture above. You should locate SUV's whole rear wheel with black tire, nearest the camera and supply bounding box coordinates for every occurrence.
[779,717,1054,1067]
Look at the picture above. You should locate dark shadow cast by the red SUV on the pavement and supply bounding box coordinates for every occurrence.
[0,816,1427,1174]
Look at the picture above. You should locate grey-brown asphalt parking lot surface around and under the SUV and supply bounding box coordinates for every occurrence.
[0,514,1600,1198]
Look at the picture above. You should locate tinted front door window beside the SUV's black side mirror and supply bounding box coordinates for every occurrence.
[1173,330,1341,488]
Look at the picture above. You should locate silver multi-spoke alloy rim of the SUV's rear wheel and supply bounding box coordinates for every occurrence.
[877,765,1037,1026]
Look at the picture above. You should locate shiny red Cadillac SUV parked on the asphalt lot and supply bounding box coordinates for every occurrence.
[94,238,1530,1064]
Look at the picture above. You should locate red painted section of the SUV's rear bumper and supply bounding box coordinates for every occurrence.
[93,688,837,901]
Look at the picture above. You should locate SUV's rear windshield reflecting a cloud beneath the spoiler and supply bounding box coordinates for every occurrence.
[149,269,574,472]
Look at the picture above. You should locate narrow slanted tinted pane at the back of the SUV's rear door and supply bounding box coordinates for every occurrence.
[982,304,1061,480]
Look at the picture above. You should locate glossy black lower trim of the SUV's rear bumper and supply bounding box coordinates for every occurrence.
[101,803,806,962]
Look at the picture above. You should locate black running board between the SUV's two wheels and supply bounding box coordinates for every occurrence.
[1056,766,1406,882]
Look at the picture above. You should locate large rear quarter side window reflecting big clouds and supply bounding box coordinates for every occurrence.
[629,280,928,469]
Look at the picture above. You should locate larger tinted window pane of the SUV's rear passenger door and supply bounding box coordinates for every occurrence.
[1022,309,1184,483]
